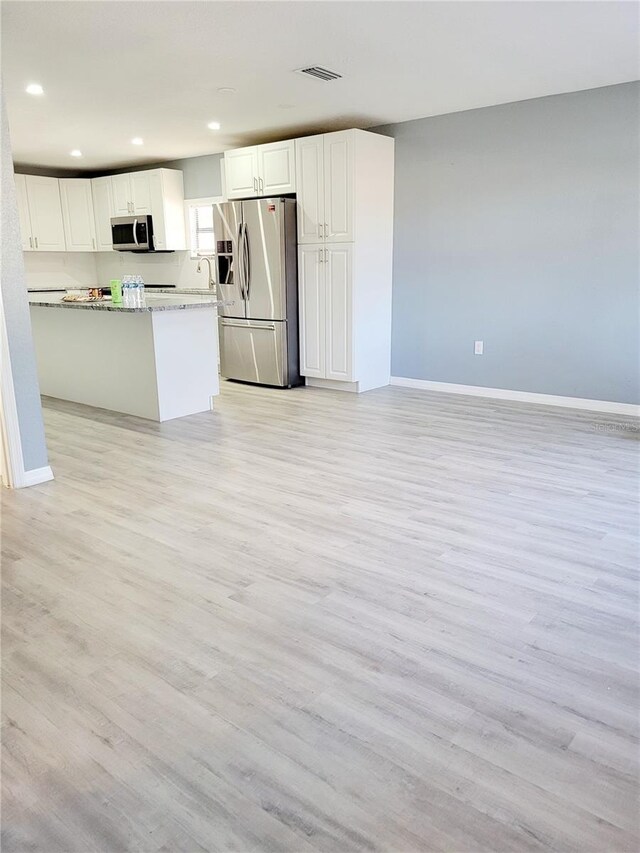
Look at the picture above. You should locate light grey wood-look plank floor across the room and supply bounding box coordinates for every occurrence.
[2,383,640,853]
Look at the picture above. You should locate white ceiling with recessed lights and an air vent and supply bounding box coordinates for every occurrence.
[1,0,640,170]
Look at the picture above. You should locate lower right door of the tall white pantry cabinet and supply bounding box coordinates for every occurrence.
[324,243,354,382]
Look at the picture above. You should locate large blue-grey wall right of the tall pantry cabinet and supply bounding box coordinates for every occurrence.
[376,83,640,403]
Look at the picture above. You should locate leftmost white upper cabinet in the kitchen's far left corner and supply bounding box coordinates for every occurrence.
[16,175,66,252]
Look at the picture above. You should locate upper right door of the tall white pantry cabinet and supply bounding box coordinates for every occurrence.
[324,130,354,243]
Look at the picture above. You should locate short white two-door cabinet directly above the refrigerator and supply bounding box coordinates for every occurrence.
[224,140,296,198]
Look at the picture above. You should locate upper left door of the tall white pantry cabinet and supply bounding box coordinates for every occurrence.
[296,136,324,243]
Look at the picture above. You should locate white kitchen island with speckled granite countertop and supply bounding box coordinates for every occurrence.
[29,292,222,421]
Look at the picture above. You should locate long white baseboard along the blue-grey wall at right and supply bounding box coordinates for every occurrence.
[391,376,640,418]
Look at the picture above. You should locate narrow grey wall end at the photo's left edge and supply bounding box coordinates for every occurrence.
[1,100,49,471]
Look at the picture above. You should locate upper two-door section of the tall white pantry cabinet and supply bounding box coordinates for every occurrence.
[296,130,356,243]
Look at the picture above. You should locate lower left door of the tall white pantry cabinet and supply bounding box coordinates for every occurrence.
[298,245,326,379]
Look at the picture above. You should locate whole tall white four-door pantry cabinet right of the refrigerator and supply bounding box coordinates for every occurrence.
[296,130,394,391]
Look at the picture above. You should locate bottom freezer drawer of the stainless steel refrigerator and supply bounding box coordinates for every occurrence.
[218,317,290,386]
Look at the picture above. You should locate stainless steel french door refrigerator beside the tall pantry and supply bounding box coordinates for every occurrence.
[213,198,301,388]
